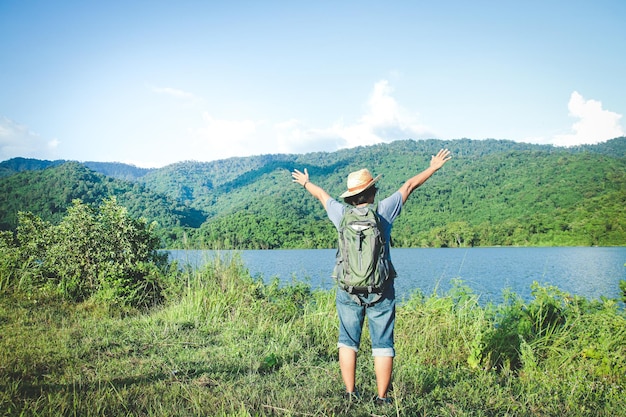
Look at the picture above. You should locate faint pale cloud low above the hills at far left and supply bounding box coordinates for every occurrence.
[0,117,59,161]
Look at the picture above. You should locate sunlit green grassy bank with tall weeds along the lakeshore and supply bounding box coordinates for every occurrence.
[0,254,626,416]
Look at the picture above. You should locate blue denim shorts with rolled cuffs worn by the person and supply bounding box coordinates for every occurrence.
[335,281,396,357]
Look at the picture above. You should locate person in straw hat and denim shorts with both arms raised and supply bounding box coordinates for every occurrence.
[291,149,451,404]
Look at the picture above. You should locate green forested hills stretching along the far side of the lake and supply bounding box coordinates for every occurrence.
[0,138,626,249]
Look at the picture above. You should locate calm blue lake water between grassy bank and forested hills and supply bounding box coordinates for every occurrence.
[169,247,626,302]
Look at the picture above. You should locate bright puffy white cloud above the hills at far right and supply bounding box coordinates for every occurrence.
[526,91,624,146]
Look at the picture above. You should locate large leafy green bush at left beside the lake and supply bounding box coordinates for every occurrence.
[0,199,167,307]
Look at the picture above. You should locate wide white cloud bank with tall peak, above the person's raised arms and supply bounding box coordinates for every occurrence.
[183,80,434,160]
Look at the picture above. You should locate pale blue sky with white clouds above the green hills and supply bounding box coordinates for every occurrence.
[0,0,626,168]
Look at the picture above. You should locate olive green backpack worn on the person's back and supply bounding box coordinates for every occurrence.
[333,205,395,305]
